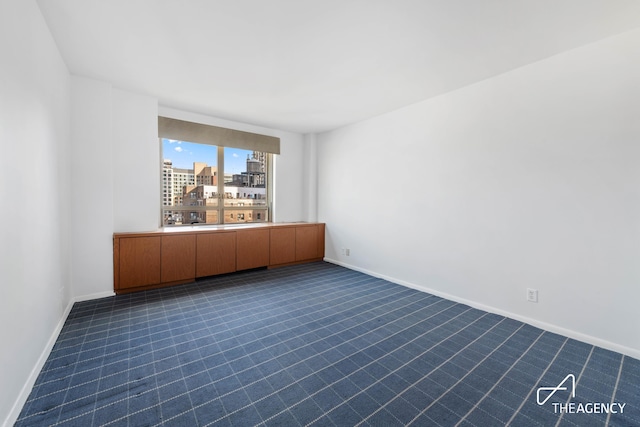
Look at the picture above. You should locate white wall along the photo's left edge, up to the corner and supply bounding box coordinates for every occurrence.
[0,0,71,424]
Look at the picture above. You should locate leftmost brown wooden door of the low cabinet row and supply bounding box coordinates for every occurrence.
[118,236,161,289]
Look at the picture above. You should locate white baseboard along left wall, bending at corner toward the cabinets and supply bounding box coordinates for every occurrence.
[2,291,115,427]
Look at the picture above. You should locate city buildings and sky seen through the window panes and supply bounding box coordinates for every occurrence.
[161,138,269,226]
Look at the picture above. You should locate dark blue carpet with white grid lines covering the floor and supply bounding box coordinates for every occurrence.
[16,262,640,427]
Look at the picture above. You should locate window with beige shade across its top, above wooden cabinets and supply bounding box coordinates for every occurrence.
[158,117,280,225]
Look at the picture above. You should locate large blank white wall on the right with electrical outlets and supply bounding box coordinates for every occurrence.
[318,31,640,357]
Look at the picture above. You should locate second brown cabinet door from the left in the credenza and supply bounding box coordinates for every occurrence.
[161,234,196,283]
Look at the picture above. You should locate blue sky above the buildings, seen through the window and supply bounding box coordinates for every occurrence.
[162,138,253,174]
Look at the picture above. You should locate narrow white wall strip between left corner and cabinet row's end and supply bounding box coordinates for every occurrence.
[68,77,113,298]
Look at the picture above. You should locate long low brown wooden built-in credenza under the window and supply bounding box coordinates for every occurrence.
[113,223,324,294]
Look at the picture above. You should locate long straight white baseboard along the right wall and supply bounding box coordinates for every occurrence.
[324,258,640,359]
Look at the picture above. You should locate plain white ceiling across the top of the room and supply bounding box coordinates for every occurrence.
[38,0,640,133]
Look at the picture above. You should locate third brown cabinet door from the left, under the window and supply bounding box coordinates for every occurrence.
[196,231,236,277]
